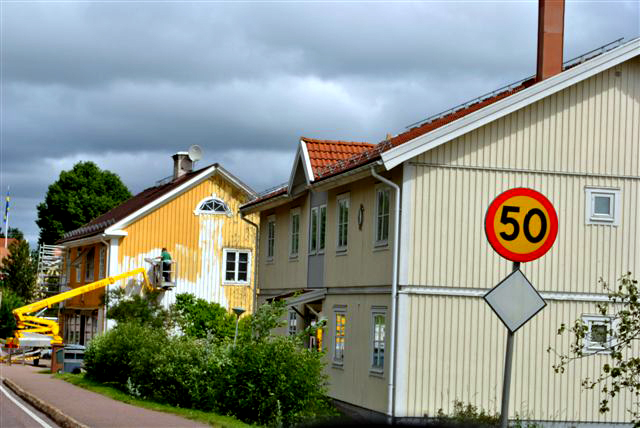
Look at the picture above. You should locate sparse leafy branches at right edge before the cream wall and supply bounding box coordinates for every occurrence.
[548,272,640,427]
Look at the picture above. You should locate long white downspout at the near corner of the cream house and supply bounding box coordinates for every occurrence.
[371,162,401,423]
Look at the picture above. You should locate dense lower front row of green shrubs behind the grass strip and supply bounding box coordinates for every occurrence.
[85,298,330,425]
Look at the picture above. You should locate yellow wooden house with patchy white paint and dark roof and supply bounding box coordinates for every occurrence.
[58,152,257,344]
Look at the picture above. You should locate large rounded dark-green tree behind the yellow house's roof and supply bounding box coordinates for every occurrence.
[36,162,131,244]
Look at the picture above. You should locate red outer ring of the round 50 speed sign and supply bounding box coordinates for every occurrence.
[484,187,558,263]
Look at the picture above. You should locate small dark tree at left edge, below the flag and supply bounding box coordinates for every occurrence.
[0,241,38,302]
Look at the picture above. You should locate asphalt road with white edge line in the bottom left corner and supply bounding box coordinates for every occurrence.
[0,384,59,428]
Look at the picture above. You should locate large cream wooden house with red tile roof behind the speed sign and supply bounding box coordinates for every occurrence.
[241,39,640,426]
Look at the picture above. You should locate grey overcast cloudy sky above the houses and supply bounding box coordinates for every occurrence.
[0,0,640,244]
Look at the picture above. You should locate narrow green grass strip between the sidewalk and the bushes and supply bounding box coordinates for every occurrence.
[54,373,254,428]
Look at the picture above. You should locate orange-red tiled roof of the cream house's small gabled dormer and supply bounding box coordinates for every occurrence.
[300,137,375,179]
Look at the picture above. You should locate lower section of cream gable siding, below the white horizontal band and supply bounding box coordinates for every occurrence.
[397,294,632,422]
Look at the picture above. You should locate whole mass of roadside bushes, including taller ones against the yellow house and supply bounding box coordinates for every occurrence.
[85,294,335,426]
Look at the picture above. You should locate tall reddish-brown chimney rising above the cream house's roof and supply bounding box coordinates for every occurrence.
[536,0,564,82]
